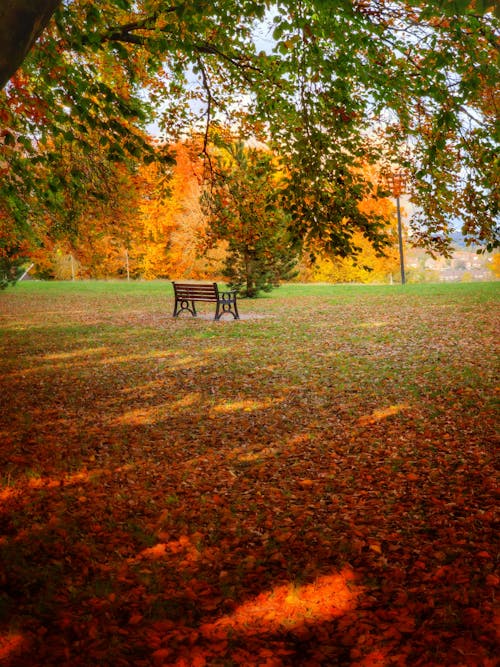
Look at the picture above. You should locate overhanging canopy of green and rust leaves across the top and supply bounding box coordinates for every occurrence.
[0,0,499,268]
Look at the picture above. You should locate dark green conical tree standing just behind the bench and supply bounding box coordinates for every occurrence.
[203,142,298,297]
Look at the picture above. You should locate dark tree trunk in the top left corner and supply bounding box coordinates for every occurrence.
[0,0,61,89]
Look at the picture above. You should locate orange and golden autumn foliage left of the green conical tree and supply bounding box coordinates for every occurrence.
[25,143,223,280]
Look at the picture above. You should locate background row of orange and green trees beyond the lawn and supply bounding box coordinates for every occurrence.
[21,140,398,296]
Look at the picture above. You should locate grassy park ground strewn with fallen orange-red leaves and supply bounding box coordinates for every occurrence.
[0,283,500,667]
